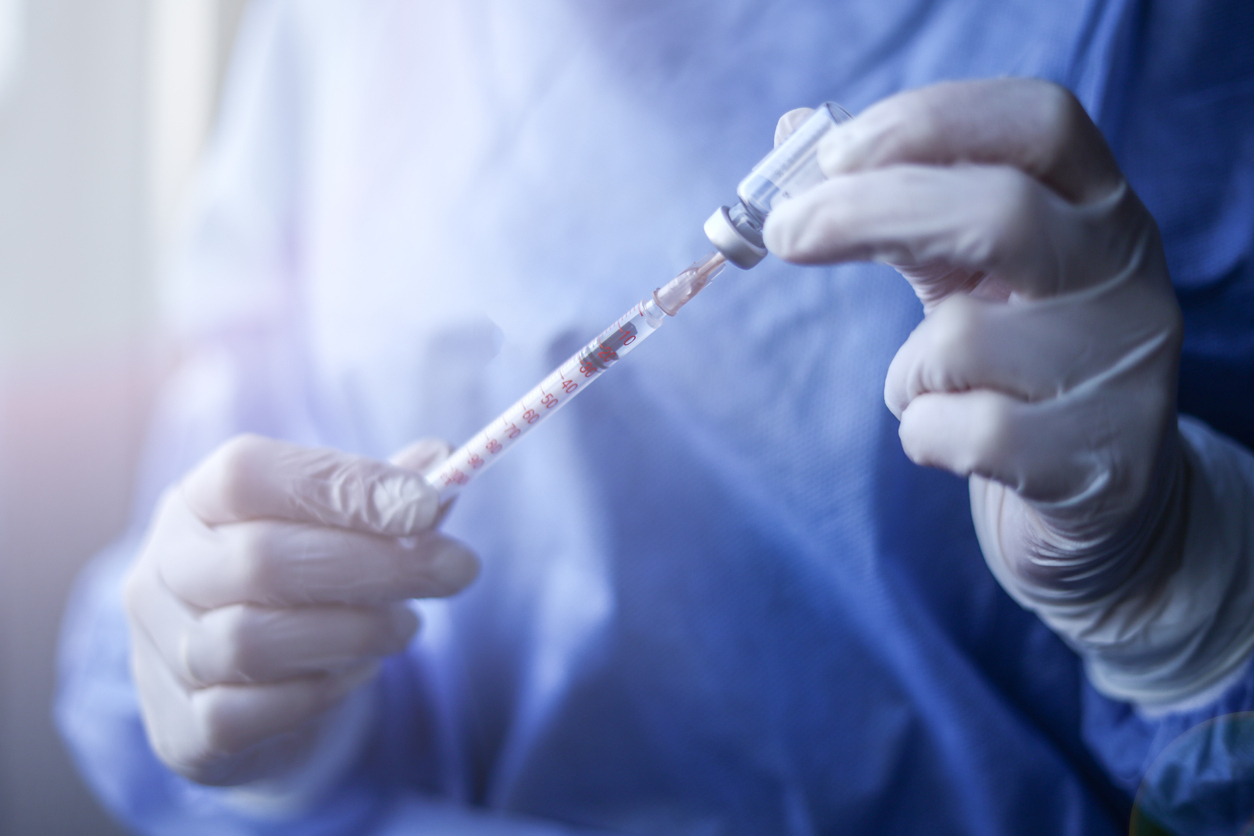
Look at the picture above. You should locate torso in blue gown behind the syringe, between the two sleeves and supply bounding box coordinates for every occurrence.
[257,0,1254,835]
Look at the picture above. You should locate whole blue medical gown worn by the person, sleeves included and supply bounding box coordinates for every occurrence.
[58,0,1254,836]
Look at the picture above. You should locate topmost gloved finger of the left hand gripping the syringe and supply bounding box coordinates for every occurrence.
[182,435,439,536]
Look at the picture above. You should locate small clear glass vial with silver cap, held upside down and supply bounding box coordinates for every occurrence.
[705,102,853,269]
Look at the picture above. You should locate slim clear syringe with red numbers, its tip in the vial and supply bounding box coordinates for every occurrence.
[426,252,726,503]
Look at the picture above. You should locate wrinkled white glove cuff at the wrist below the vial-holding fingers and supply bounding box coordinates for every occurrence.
[981,419,1254,712]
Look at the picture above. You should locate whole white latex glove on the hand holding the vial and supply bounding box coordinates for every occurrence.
[765,79,1254,706]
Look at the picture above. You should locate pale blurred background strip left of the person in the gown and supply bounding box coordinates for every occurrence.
[0,0,245,836]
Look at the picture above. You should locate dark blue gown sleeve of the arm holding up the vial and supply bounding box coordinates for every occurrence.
[1082,0,1254,822]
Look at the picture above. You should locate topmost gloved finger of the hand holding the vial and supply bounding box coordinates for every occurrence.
[819,79,1122,203]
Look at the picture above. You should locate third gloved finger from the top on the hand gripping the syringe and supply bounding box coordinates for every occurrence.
[181,604,418,687]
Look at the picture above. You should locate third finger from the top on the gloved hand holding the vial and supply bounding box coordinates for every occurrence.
[884,282,1179,417]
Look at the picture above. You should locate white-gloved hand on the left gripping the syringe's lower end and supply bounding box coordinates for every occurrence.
[125,436,478,785]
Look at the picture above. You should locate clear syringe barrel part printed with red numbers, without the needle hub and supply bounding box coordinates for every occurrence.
[433,300,665,493]
